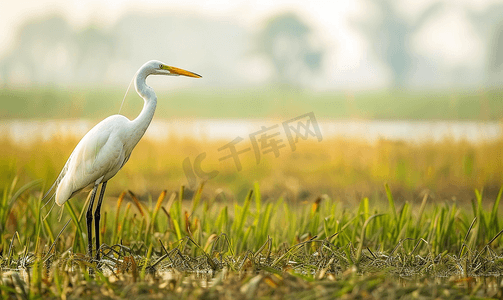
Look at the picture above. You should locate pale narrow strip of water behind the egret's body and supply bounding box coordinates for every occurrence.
[0,119,503,144]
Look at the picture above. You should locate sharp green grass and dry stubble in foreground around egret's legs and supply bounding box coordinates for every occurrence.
[0,179,503,299]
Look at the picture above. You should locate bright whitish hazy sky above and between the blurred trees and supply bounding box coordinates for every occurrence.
[0,0,502,86]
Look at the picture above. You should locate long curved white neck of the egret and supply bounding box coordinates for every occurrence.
[131,70,157,147]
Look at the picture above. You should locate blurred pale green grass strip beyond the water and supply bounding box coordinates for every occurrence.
[0,87,503,121]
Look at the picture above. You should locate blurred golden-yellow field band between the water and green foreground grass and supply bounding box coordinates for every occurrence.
[0,132,503,203]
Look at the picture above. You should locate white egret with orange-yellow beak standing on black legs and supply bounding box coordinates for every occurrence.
[48,60,201,260]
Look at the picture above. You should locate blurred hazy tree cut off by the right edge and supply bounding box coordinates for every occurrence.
[467,4,503,87]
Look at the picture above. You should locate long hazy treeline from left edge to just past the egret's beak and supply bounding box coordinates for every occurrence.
[0,12,250,86]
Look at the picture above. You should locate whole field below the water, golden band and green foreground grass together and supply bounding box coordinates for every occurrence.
[0,134,503,299]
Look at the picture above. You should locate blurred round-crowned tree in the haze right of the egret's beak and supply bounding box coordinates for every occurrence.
[257,13,324,85]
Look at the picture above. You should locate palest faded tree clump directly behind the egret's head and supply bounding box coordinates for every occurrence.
[111,12,249,86]
